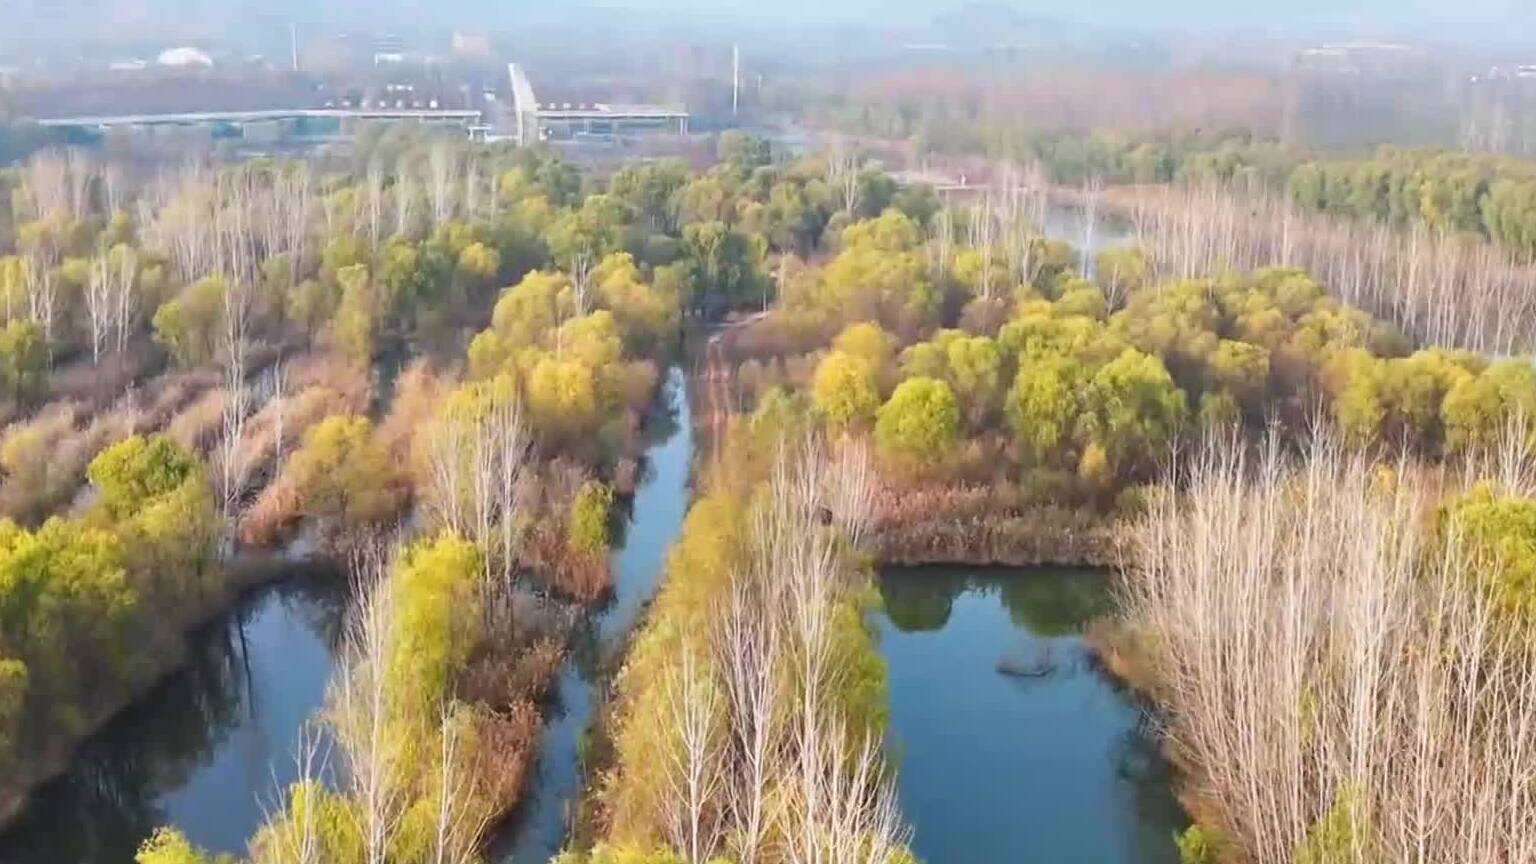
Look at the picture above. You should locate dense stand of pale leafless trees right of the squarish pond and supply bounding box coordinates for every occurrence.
[1121,430,1536,864]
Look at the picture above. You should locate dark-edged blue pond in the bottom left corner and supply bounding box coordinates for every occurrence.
[0,567,346,864]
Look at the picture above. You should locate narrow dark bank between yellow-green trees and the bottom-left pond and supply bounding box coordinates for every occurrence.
[0,552,342,832]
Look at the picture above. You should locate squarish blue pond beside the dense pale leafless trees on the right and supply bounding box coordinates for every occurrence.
[879,567,1187,864]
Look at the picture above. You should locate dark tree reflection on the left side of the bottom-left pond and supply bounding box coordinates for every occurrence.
[0,568,346,864]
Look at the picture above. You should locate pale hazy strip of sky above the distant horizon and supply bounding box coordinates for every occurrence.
[0,0,1536,42]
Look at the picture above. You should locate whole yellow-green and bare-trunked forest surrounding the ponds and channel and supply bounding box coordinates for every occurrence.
[0,122,1536,864]
